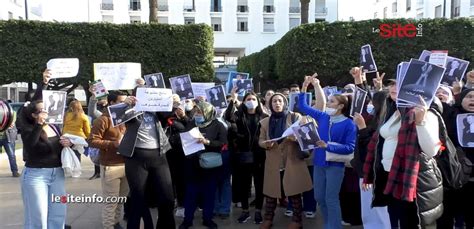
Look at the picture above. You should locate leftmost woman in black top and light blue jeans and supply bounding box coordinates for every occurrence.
[18,100,72,228]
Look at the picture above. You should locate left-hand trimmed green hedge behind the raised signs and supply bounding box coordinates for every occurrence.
[0,20,214,87]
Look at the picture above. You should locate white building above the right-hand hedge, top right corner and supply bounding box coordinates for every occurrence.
[373,0,474,19]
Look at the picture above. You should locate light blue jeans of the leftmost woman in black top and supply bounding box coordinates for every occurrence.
[21,167,67,229]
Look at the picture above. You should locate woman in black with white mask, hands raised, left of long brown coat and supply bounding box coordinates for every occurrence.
[226,92,267,224]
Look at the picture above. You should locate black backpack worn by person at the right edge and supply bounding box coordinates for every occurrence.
[430,109,472,189]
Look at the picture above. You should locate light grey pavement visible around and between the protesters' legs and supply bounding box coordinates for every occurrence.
[0,149,362,229]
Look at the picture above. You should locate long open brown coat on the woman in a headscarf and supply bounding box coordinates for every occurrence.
[259,112,313,198]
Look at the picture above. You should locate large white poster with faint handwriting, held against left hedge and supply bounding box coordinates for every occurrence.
[94,63,142,90]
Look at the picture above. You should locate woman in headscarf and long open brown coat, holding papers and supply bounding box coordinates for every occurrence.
[259,93,312,229]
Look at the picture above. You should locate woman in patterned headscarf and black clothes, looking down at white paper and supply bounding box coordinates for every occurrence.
[179,102,227,229]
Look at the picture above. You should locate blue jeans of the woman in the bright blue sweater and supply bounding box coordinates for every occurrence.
[313,166,344,229]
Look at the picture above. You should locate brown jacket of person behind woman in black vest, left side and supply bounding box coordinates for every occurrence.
[87,113,125,166]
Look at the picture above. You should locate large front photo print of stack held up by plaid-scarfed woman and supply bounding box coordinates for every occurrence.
[397,59,445,106]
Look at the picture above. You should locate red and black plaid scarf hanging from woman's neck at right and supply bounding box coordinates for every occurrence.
[364,108,421,202]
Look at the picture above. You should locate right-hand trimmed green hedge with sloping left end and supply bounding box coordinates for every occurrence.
[238,18,474,89]
